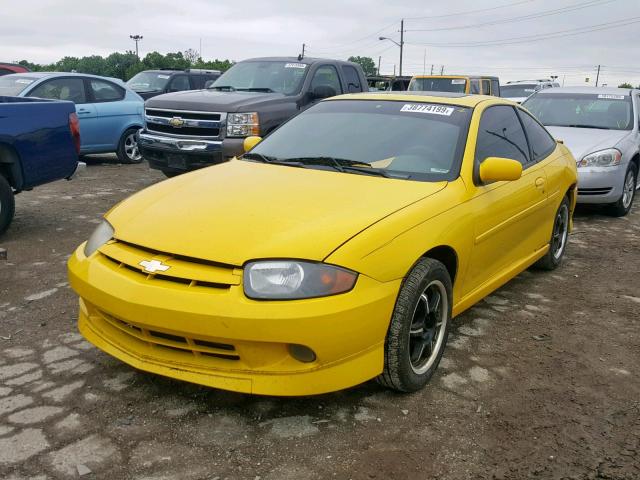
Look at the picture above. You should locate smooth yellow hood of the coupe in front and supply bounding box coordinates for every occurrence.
[106,160,447,266]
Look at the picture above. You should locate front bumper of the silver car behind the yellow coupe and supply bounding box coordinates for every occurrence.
[578,164,627,203]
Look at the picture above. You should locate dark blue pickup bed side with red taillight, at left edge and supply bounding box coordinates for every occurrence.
[0,97,78,189]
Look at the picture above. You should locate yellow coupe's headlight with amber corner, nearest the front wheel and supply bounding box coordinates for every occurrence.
[244,260,358,300]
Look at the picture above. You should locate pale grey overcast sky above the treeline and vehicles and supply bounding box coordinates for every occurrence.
[0,0,640,86]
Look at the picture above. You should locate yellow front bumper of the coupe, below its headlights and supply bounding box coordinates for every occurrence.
[69,246,400,396]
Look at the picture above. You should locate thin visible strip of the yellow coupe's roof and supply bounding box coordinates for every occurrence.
[327,92,498,108]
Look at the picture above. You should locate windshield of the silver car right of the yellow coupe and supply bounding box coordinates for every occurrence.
[522,93,633,130]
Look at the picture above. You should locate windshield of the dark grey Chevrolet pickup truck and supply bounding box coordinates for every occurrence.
[209,61,308,95]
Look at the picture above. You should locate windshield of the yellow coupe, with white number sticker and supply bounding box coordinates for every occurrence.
[245,100,471,182]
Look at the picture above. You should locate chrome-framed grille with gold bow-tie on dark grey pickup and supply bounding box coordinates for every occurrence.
[145,108,226,138]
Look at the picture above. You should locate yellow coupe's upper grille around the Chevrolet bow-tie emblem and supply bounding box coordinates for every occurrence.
[99,240,242,290]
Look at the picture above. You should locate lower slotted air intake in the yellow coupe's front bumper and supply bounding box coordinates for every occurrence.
[98,311,240,360]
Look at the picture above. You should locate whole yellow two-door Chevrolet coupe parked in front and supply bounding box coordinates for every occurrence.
[69,94,576,395]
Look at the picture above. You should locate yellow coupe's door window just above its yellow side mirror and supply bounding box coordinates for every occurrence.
[476,105,529,166]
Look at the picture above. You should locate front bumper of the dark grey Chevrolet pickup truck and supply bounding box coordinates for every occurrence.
[138,130,243,173]
